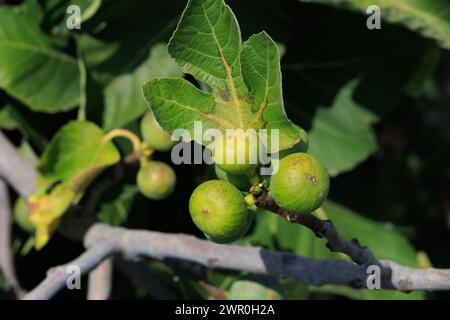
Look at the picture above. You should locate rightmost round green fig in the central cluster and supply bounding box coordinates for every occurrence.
[269,153,330,213]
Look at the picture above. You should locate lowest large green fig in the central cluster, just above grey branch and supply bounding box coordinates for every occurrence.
[189,180,249,243]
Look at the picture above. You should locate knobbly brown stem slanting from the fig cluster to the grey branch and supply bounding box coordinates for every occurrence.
[255,189,390,277]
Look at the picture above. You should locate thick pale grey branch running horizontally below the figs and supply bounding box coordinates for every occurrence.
[25,224,450,299]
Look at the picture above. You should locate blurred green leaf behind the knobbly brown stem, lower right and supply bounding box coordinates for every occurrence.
[244,201,424,299]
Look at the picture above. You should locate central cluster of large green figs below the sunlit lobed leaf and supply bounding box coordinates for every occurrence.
[189,129,330,243]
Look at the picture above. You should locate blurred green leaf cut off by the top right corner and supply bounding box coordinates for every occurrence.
[299,0,450,49]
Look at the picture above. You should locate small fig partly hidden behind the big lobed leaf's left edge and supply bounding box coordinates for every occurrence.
[141,112,176,151]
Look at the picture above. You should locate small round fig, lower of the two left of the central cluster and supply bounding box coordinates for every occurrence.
[136,161,177,200]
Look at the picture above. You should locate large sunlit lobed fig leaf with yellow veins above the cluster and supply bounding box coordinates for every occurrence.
[144,0,301,152]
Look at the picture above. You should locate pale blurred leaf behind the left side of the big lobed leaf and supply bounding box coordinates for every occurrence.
[103,44,182,130]
